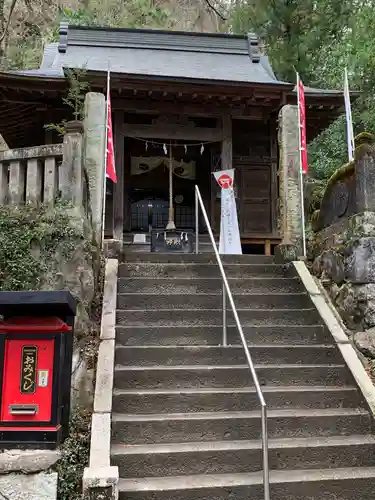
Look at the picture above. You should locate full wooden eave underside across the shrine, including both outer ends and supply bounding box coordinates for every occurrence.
[0,72,352,147]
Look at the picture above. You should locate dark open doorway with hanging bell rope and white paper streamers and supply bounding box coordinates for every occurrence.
[128,138,210,232]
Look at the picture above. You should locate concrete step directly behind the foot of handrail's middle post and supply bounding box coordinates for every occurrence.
[116,324,332,346]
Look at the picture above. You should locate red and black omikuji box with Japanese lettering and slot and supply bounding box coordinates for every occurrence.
[0,291,76,448]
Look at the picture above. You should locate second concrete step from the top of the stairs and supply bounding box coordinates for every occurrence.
[118,261,296,278]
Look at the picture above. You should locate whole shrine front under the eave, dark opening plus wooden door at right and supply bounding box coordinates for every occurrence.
[108,107,279,251]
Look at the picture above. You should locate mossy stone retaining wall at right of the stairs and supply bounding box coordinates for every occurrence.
[309,144,375,357]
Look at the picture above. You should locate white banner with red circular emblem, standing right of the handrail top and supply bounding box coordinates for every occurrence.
[213,169,242,255]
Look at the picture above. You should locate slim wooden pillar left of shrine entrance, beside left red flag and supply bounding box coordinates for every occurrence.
[113,110,124,241]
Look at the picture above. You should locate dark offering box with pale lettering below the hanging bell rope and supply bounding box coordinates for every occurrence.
[151,229,194,253]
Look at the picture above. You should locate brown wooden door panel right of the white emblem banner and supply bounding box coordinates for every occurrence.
[236,165,272,237]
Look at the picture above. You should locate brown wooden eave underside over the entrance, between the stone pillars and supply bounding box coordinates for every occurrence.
[86,72,292,120]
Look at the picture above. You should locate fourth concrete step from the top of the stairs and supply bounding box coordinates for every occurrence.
[117,289,312,310]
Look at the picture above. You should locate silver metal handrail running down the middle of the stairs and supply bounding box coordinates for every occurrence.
[195,185,270,500]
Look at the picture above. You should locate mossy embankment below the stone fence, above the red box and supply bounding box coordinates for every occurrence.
[0,204,101,334]
